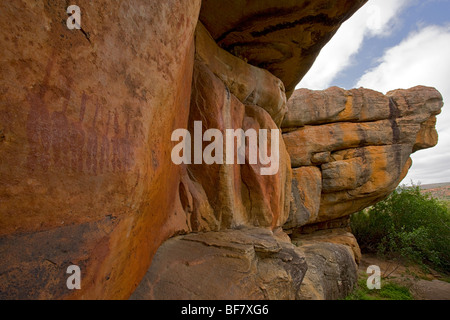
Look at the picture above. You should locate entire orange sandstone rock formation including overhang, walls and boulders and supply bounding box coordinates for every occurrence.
[0,0,442,299]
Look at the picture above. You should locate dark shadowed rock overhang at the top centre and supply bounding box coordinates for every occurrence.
[200,0,367,97]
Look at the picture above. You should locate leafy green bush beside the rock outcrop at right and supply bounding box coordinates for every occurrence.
[350,186,450,272]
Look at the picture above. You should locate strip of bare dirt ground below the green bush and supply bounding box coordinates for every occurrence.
[359,255,450,300]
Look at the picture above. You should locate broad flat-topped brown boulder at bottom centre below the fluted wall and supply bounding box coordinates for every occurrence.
[131,228,307,300]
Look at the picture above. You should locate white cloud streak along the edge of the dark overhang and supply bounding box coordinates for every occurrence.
[297,0,411,90]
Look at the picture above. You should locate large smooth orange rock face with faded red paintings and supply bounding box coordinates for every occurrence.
[0,0,200,299]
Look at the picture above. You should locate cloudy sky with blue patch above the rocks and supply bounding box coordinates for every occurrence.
[298,0,450,184]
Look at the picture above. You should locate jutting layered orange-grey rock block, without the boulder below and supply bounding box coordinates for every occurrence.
[282,86,443,228]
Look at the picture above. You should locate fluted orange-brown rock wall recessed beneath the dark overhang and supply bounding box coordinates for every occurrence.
[180,25,292,231]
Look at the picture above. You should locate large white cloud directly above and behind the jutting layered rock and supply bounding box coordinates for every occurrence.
[357,26,450,184]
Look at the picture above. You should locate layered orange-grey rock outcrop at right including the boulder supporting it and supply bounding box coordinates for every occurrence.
[282,86,443,300]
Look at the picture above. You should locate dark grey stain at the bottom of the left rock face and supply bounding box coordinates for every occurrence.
[0,218,117,300]
